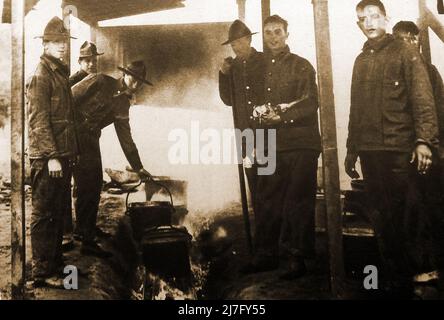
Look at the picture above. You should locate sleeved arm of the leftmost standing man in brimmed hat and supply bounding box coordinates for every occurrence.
[27,73,58,158]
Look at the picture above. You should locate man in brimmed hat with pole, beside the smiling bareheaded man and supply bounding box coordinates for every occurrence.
[219,20,265,212]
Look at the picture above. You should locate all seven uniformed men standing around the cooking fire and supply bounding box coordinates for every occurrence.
[27,0,444,292]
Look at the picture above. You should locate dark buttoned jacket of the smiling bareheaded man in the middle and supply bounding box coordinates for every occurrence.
[265,46,321,152]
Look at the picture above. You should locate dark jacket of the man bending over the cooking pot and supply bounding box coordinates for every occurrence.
[72,73,143,170]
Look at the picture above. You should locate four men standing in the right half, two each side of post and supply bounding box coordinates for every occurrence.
[219,0,444,296]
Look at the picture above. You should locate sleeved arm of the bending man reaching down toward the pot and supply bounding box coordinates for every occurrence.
[114,106,143,171]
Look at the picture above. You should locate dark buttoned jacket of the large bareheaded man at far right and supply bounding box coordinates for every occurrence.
[347,34,438,153]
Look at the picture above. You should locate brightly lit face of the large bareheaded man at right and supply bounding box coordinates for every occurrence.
[356,6,387,40]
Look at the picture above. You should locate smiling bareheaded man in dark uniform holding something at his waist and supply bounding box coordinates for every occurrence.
[241,15,321,280]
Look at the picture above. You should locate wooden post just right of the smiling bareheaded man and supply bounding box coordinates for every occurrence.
[313,0,344,297]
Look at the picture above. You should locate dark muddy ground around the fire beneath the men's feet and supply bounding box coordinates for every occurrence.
[0,185,444,300]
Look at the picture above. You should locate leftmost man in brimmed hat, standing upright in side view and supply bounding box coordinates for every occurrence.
[27,17,78,288]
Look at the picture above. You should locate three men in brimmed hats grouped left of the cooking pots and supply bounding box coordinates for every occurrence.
[26,17,151,288]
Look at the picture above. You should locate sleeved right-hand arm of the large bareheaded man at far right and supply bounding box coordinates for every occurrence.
[402,46,438,147]
